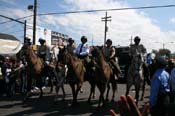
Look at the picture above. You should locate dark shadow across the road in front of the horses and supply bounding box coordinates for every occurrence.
[0,92,117,116]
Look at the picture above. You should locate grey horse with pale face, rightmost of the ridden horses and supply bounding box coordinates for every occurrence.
[125,54,145,104]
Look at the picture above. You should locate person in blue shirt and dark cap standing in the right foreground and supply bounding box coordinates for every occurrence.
[150,56,170,116]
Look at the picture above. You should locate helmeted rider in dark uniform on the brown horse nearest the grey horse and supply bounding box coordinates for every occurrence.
[102,39,121,76]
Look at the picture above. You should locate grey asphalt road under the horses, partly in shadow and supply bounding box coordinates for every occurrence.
[0,82,149,116]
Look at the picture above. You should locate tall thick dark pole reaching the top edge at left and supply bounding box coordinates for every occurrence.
[33,0,37,45]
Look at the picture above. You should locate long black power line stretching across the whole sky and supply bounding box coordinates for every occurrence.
[0,4,175,24]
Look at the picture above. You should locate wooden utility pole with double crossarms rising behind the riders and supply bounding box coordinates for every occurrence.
[101,11,111,45]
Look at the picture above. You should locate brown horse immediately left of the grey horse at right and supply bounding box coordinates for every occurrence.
[91,47,116,108]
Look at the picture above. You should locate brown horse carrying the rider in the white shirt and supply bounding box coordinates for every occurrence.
[59,48,85,106]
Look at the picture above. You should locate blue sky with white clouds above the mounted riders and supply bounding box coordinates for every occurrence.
[0,0,175,52]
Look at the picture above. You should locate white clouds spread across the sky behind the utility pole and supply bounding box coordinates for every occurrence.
[0,0,175,51]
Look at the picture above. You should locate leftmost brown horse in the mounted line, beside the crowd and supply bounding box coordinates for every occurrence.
[17,45,45,101]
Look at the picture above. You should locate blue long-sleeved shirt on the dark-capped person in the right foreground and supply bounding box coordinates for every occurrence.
[150,68,170,107]
